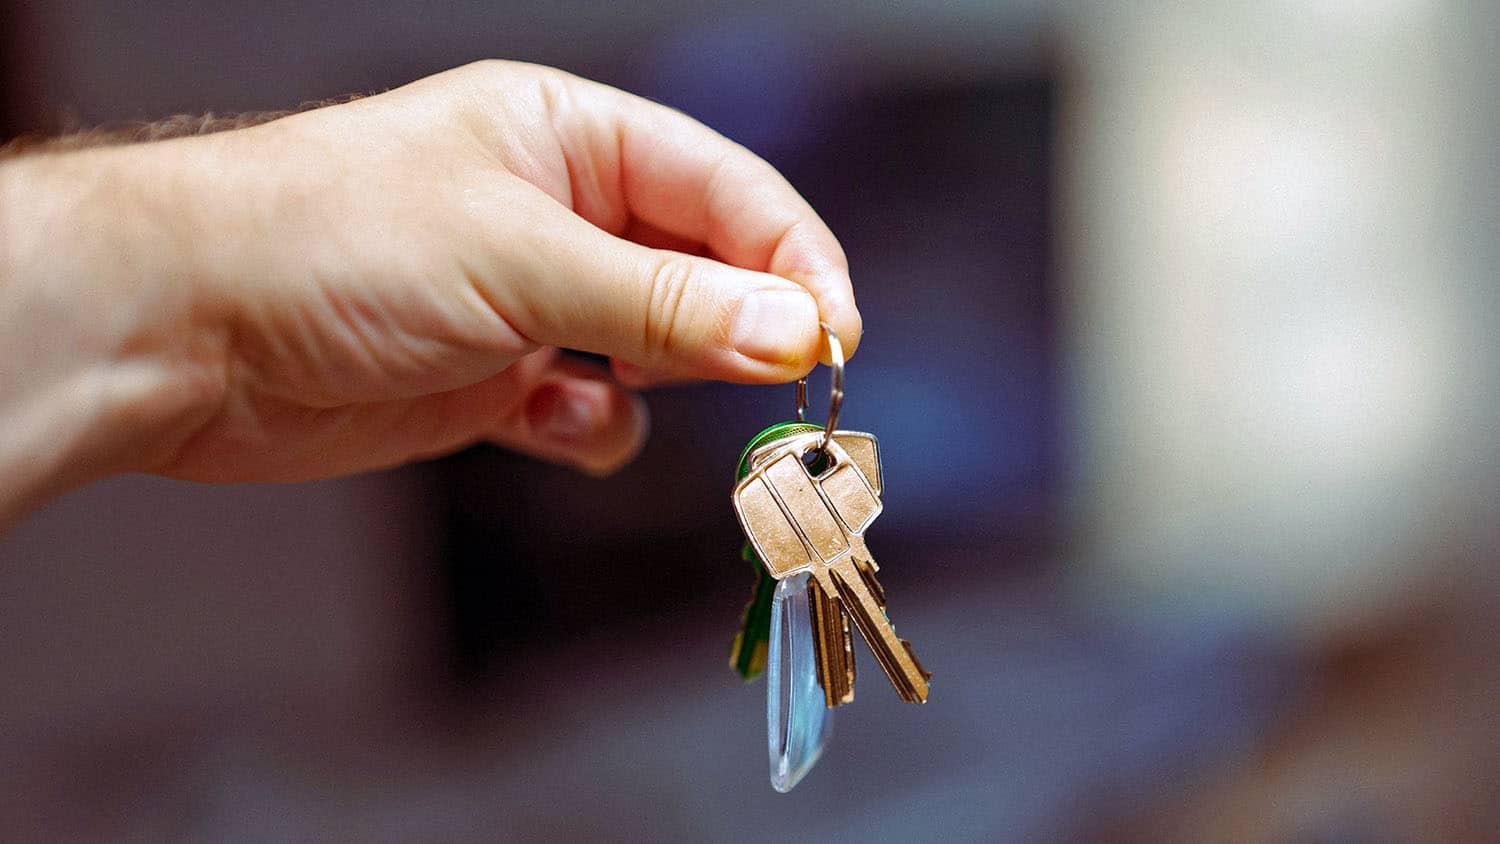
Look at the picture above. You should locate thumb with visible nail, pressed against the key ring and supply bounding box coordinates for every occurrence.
[494,197,822,382]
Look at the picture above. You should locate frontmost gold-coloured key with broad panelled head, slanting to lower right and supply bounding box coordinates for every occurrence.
[734,424,932,703]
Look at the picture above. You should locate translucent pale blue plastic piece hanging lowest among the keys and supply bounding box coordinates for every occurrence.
[765,574,834,795]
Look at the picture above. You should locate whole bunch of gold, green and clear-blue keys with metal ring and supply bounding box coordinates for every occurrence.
[731,325,932,792]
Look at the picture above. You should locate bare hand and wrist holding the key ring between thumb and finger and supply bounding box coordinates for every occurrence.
[0,61,860,520]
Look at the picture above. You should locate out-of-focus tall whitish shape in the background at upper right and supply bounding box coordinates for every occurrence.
[1058,0,1500,635]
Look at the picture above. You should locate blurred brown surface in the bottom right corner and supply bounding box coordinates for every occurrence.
[1079,561,1500,843]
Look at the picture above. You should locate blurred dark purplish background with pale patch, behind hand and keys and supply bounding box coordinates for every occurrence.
[0,0,1500,843]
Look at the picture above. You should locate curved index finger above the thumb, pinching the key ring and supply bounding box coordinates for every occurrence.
[548,75,863,355]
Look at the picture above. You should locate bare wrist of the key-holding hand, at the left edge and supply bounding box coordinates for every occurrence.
[0,145,228,526]
